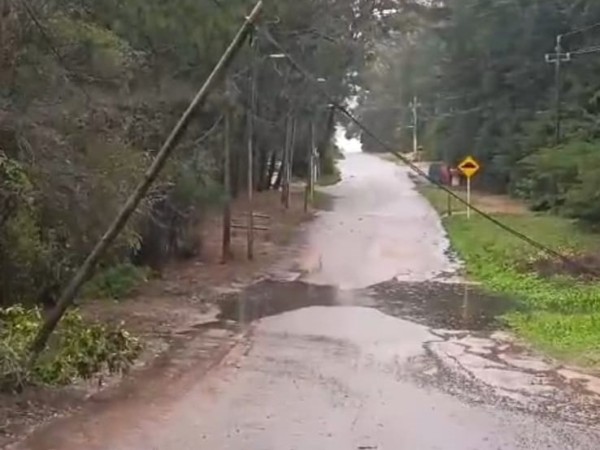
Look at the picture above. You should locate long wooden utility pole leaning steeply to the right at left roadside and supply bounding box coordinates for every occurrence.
[29,0,262,366]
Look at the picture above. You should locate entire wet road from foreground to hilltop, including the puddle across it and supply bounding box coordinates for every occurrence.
[12,154,600,450]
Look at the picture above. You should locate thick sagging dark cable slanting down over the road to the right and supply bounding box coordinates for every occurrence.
[260,28,597,275]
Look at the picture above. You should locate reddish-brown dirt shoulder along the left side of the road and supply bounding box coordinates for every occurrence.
[0,190,312,448]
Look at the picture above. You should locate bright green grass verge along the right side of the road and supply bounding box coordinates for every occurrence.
[422,187,600,366]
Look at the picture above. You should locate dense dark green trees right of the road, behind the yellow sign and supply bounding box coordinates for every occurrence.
[360,0,600,225]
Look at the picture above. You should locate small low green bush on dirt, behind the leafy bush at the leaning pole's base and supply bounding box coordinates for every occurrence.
[84,263,150,300]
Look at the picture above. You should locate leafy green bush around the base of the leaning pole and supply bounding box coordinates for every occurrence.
[0,306,141,391]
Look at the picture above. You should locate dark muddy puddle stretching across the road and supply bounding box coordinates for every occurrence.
[220,280,515,331]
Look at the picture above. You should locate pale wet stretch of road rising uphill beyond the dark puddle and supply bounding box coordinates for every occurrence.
[296,154,455,288]
